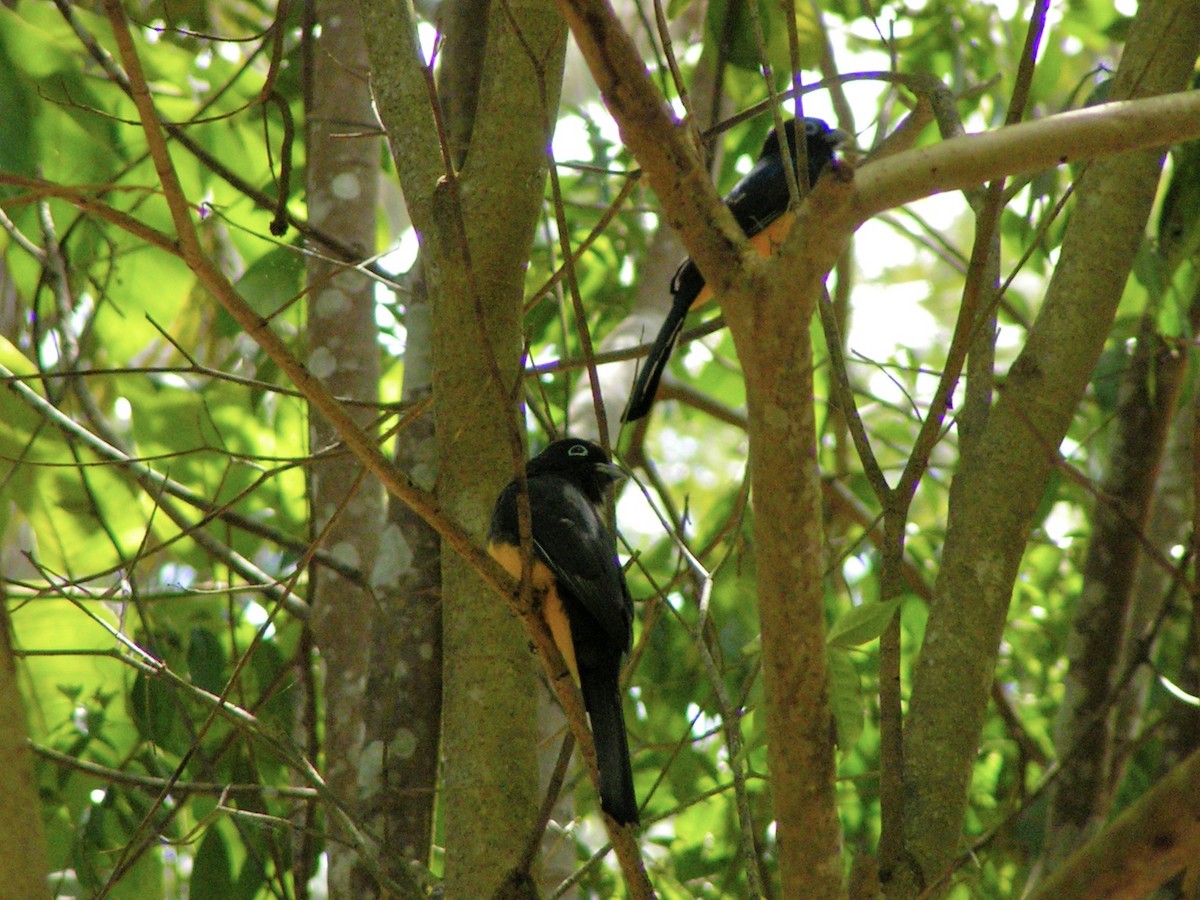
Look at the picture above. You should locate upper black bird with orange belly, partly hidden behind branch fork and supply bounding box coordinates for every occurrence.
[620,119,847,422]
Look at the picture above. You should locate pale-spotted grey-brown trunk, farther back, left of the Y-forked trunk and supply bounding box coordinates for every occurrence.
[305,0,383,896]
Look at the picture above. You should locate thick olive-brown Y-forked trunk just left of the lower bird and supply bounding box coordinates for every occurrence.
[360,0,565,896]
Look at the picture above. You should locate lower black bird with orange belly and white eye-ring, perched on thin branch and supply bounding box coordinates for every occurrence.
[487,438,637,824]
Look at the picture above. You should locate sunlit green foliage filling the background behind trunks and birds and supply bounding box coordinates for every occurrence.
[0,0,1195,898]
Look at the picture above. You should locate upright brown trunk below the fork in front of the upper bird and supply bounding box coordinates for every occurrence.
[726,278,844,898]
